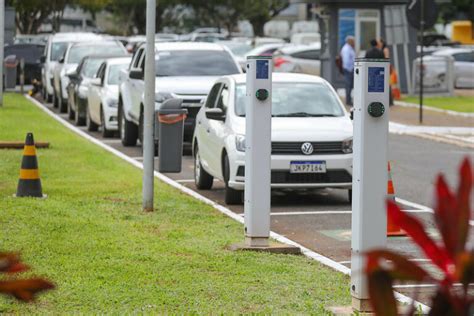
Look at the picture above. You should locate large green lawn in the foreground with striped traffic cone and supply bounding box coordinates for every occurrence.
[0,94,350,314]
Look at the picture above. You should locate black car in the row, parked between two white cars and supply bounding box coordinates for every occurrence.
[66,55,123,126]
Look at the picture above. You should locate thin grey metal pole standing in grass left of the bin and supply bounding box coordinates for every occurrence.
[142,0,156,212]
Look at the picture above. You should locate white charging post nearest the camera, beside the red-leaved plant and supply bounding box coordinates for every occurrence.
[351,59,389,312]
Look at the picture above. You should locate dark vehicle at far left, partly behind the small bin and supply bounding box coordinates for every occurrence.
[3,43,45,84]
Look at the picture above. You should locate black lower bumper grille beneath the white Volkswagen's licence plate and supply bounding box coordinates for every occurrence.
[237,166,352,184]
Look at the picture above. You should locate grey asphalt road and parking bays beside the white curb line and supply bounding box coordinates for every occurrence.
[39,99,474,304]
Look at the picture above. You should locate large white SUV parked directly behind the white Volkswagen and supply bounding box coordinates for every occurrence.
[118,42,242,146]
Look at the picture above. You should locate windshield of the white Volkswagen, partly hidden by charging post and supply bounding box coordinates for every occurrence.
[235,82,344,117]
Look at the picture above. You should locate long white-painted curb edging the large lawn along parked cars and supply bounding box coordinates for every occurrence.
[24,95,430,314]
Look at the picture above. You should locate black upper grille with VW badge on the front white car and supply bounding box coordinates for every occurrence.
[272,142,344,156]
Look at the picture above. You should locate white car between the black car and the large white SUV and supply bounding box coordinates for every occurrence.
[87,57,132,137]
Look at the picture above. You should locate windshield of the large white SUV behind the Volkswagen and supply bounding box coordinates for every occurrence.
[155,50,239,77]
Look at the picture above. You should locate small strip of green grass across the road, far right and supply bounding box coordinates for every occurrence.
[402,96,474,113]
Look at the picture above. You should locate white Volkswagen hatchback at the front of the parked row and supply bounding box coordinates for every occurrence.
[193,73,352,204]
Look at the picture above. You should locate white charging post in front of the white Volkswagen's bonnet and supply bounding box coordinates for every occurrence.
[244,56,273,247]
